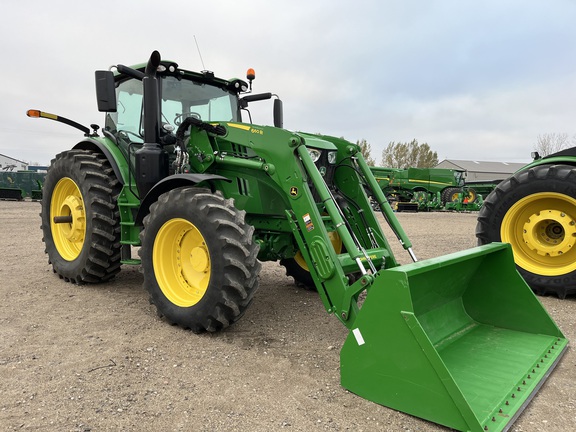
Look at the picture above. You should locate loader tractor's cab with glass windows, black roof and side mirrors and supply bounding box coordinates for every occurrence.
[96,61,282,145]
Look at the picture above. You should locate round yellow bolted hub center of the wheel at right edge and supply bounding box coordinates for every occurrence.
[523,209,576,256]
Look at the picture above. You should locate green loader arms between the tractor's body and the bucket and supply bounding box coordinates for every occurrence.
[187,122,400,327]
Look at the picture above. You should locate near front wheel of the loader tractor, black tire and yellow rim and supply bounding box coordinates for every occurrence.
[140,187,261,333]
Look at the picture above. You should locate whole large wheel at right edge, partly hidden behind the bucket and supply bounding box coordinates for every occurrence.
[476,165,576,298]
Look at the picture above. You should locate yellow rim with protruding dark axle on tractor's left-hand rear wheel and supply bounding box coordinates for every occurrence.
[50,177,86,261]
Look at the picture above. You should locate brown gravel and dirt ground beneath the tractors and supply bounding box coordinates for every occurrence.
[0,201,576,431]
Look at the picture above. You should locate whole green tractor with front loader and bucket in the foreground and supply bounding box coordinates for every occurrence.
[28,51,568,431]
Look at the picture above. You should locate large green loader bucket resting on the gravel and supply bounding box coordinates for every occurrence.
[340,243,568,431]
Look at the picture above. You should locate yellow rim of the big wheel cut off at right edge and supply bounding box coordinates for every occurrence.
[500,192,576,276]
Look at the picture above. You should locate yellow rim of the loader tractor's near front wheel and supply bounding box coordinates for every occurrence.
[152,218,210,307]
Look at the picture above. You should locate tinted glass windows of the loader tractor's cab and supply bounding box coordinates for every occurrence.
[106,76,238,143]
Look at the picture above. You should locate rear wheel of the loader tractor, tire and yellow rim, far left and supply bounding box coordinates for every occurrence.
[40,150,121,284]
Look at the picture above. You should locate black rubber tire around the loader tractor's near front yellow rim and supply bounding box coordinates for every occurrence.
[139,187,261,333]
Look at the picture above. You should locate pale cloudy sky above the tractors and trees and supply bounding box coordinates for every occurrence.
[0,0,576,165]
